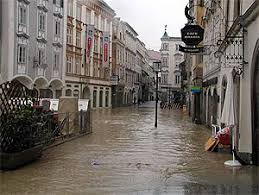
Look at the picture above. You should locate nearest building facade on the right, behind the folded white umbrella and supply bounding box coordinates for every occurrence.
[188,0,259,165]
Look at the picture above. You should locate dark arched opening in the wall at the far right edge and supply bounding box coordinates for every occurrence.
[250,39,259,165]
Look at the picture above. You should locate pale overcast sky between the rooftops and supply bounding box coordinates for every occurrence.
[105,0,188,50]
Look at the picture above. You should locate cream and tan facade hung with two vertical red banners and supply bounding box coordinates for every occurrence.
[64,0,115,108]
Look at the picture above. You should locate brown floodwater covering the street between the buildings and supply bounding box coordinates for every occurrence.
[0,103,259,194]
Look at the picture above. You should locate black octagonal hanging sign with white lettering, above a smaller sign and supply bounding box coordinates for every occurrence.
[181,24,204,46]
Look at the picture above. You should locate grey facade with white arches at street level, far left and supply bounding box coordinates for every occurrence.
[1,0,64,98]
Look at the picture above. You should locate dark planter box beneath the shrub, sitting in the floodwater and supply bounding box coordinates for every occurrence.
[0,145,43,170]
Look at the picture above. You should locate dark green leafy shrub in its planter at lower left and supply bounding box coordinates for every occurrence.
[0,105,47,169]
